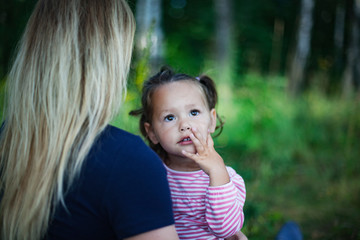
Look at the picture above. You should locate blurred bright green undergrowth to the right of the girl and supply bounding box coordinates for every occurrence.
[217,75,360,239]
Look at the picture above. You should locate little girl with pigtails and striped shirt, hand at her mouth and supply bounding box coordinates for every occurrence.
[130,67,246,239]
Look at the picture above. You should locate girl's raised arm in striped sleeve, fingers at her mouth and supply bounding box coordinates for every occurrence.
[183,129,246,238]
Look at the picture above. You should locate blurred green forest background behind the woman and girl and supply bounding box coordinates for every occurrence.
[0,0,360,240]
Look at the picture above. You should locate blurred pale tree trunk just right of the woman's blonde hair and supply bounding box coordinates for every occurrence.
[135,0,163,71]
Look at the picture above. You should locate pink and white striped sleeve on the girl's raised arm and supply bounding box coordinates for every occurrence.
[205,168,246,238]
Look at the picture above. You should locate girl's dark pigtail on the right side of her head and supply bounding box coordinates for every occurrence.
[196,75,225,137]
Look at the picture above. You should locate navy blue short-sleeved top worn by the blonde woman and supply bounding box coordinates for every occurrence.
[46,126,174,240]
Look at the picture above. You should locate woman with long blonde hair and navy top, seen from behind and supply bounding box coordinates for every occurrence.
[0,0,178,240]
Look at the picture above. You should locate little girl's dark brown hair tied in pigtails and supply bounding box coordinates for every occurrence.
[129,66,224,160]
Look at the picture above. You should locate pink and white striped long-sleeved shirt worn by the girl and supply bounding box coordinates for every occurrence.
[165,166,246,240]
